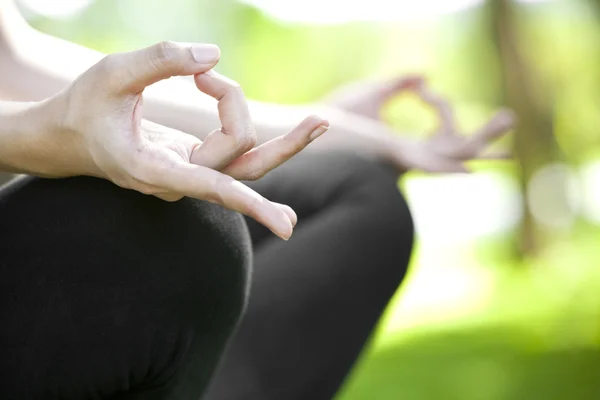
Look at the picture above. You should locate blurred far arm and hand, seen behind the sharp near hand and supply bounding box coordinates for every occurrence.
[0,0,515,172]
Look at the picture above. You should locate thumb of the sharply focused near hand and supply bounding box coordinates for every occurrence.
[104,42,221,94]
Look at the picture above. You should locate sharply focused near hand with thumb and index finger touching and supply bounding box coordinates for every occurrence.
[45,43,328,240]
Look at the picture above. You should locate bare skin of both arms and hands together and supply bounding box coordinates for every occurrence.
[0,0,515,240]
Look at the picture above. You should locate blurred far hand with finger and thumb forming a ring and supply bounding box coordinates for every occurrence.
[328,75,516,172]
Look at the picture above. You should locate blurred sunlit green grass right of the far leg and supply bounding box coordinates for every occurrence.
[337,229,600,400]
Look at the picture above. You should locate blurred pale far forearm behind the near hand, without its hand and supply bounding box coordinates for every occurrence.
[0,2,398,162]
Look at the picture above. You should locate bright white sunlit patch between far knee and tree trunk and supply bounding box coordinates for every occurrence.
[384,173,523,333]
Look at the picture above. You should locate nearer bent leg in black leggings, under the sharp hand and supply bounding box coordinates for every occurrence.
[0,178,251,400]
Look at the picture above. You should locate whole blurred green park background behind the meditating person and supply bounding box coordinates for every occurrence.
[21,0,600,400]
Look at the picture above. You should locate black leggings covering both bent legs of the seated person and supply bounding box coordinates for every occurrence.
[0,154,413,400]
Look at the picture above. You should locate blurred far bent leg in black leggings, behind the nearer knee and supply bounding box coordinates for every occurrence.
[205,154,413,400]
